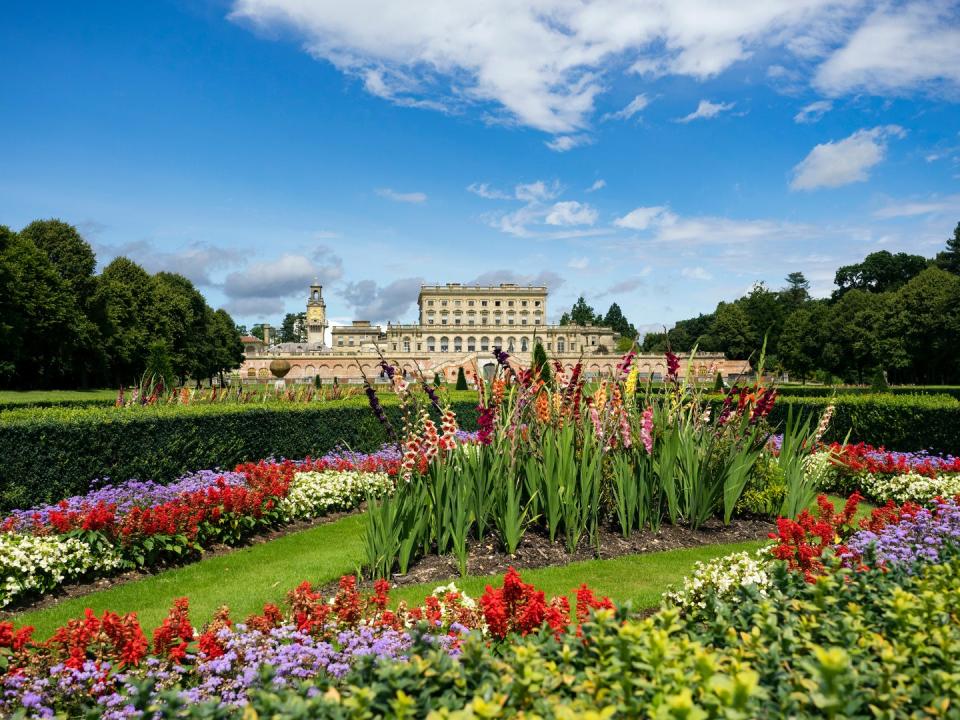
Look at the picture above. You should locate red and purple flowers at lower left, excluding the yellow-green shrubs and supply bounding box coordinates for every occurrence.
[0,571,612,718]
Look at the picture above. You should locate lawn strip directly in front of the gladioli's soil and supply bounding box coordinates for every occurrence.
[390,540,766,608]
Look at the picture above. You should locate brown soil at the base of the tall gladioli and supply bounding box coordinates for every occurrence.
[338,518,776,595]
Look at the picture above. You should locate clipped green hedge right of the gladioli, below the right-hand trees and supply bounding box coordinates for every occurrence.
[770,393,960,454]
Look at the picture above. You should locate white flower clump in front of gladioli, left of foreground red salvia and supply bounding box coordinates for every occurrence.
[664,550,770,613]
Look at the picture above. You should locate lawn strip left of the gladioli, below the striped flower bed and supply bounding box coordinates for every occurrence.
[14,515,364,638]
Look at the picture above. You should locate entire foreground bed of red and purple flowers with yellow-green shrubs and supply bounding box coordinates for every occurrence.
[0,490,960,718]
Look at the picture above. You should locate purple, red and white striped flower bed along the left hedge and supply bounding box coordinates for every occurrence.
[0,449,400,607]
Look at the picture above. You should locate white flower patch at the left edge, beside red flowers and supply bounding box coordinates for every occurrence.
[0,533,121,607]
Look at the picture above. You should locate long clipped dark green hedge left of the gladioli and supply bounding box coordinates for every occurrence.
[0,392,477,510]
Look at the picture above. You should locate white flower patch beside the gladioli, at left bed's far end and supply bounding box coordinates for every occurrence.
[278,470,393,521]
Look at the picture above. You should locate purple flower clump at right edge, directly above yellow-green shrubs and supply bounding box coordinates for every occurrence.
[847,500,960,569]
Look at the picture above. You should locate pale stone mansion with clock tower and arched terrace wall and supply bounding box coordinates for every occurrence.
[239,283,748,384]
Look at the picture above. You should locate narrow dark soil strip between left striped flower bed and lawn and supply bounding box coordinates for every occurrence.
[0,504,366,619]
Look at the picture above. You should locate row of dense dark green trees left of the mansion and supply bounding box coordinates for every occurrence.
[0,220,243,389]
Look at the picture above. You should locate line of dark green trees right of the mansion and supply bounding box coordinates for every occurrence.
[642,223,960,384]
